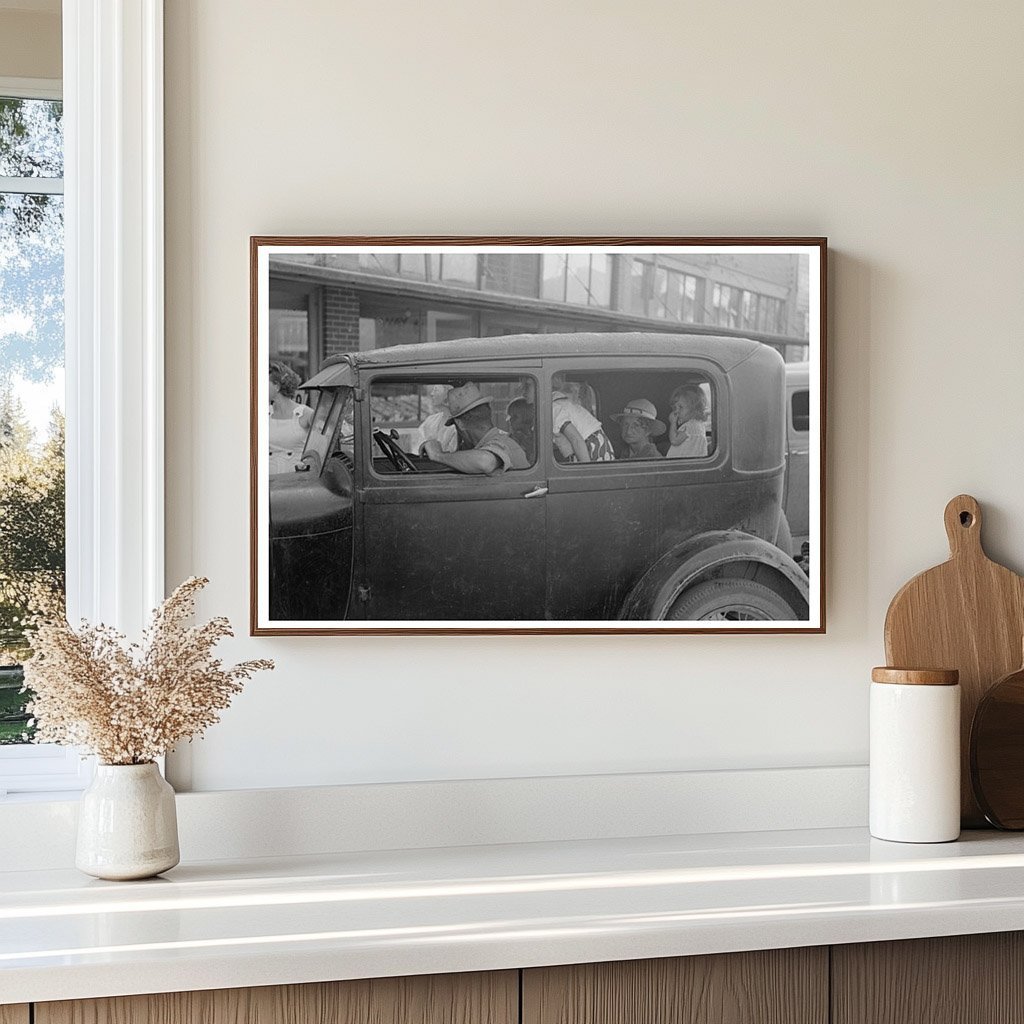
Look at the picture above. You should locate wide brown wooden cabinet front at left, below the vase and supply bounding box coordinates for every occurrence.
[37,971,519,1024]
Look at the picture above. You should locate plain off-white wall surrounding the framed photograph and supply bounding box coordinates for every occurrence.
[159,0,1024,790]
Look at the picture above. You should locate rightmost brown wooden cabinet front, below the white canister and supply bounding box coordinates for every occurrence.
[831,932,1024,1024]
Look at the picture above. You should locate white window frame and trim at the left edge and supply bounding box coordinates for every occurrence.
[0,0,164,799]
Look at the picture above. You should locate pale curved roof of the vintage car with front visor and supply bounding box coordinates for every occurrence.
[302,332,767,387]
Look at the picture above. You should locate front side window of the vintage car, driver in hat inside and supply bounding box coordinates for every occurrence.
[370,375,537,476]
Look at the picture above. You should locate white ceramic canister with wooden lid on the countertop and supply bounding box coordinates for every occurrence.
[870,669,961,843]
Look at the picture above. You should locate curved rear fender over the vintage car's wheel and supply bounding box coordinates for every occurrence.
[618,529,809,620]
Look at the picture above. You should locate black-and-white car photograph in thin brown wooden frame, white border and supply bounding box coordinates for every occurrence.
[250,237,826,635]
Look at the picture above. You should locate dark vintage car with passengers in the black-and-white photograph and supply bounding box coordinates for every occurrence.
[269,333,809,624]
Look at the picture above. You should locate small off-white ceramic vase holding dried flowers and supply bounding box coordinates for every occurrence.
[75,761,180,882]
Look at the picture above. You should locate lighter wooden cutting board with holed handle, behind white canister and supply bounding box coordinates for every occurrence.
[886,495,1024,828]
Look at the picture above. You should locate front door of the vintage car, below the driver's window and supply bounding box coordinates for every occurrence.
[349,372,548,627]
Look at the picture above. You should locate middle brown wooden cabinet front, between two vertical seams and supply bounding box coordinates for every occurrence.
[522,947,828,1024]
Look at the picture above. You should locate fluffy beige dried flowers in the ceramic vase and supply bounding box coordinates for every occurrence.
[25,577,273,765]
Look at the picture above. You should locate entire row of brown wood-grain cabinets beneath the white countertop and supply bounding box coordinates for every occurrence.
[16,932,1024,1024]
